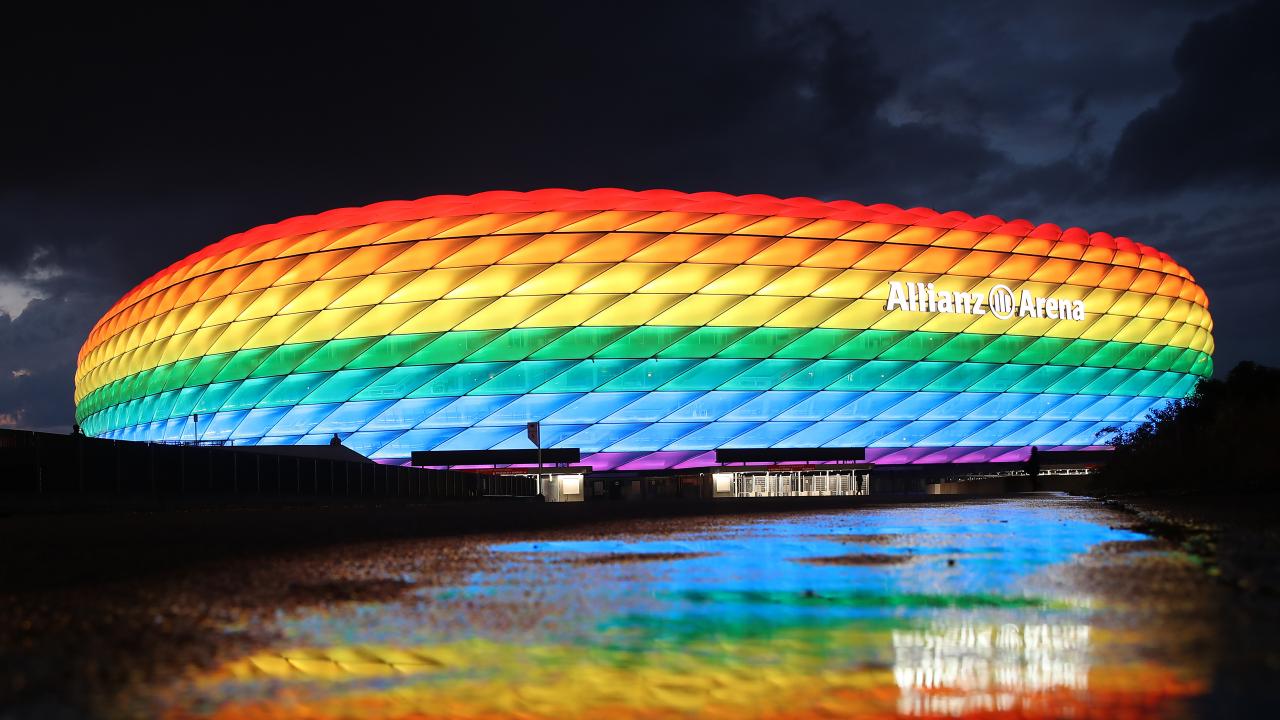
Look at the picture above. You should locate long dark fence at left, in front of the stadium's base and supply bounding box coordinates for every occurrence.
[0,429,538,501]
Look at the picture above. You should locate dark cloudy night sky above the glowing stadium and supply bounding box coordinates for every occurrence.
[0,0,1280,428]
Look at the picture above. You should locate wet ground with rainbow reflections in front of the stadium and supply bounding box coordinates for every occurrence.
[0,495,1280,719]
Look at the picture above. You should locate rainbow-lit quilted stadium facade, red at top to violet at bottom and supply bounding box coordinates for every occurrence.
[76,190,1213,470]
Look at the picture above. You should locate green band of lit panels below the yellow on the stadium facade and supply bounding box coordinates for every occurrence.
[77,327,1212,420]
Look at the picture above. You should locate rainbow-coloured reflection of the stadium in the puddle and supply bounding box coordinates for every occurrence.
[165,501,1203,719]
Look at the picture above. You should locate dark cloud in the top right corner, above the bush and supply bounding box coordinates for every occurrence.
[1111,3,1280,192]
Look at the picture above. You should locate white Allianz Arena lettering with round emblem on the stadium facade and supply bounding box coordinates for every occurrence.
[884,281,1084,320]
